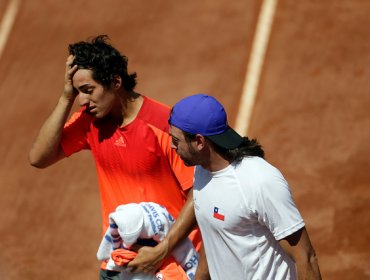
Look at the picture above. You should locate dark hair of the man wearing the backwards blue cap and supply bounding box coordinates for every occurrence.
[183,131,265,163]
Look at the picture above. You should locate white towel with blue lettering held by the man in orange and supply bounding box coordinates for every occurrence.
[97,202,198,279]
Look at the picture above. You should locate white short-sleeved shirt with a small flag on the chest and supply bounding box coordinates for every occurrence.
[194,157,304,280]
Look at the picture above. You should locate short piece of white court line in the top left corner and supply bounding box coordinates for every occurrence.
[0,0,21,58]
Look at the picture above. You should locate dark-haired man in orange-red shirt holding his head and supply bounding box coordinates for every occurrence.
[29,35,200,279]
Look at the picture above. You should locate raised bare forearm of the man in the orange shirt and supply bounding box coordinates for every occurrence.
[29,96,73,168]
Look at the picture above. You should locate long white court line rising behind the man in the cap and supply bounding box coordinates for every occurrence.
[235,0,277,135]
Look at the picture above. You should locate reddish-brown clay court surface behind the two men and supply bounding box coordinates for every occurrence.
[0,0,370,280]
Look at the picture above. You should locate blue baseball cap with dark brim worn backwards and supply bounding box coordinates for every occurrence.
[169,93,243,149]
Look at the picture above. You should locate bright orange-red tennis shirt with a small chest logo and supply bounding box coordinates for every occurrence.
[61,96,199,232]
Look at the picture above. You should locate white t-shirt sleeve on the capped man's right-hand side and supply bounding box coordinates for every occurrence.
[256,170,304,240]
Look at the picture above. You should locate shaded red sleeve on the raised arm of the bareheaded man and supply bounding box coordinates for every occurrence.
[61,111,90,157]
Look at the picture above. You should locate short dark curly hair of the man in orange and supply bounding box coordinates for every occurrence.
[68,35,136,91]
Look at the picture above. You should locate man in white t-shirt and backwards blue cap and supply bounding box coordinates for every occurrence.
[127,94,321,280]
